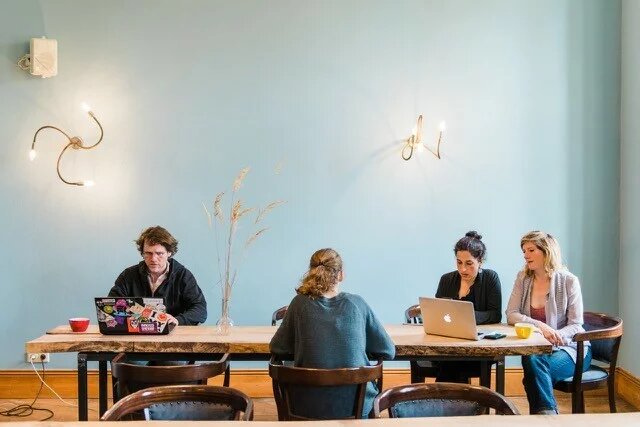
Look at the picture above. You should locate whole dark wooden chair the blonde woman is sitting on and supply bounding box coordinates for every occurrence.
[553,312,623,414]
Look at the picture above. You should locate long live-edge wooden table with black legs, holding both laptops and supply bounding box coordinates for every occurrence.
[25,325,551,421]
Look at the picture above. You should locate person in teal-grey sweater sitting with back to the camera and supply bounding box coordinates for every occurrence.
[269,249,395,418]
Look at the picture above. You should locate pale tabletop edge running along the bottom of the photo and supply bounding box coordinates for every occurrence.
[3,412,640,427]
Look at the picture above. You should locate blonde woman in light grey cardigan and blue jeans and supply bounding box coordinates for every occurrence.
[506,231,591,414]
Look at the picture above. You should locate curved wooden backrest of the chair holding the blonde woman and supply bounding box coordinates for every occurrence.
[576,311,623,367]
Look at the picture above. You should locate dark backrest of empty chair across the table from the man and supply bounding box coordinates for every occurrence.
[111,353,229,399]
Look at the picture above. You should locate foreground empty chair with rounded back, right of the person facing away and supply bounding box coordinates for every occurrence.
[373,383,520,424]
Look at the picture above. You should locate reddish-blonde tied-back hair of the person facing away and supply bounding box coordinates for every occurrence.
[296,248,342,298]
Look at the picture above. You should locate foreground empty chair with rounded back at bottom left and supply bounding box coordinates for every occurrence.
[100,385,253,421]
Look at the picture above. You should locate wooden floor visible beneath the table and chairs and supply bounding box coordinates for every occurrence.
[0,395,638,422]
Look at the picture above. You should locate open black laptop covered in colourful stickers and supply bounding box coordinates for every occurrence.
[95,297,174,335]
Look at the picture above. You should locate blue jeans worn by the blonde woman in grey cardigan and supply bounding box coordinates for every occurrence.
[522,346,591,414]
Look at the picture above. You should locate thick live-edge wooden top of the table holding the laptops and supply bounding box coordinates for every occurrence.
[25,324,552,358]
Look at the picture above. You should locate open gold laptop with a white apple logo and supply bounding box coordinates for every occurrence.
[420,297,483,340]
